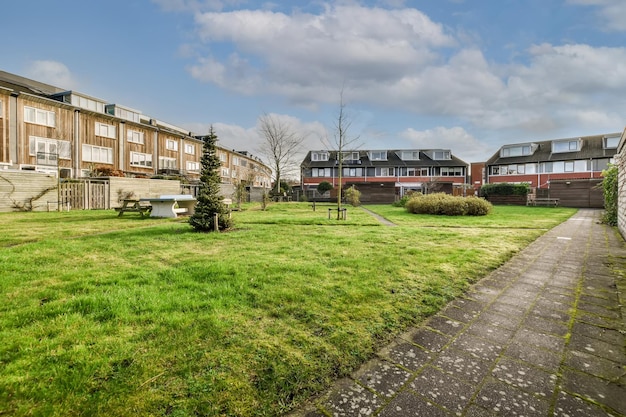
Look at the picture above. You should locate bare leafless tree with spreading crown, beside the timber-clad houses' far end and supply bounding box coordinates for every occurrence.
[258,113,305,194]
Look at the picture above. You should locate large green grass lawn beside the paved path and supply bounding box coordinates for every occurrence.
[0,203,574,416]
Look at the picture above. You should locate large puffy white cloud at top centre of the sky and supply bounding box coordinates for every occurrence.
[190,5,454,103]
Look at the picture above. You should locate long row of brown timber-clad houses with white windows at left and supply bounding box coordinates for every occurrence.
[0,71,272,190]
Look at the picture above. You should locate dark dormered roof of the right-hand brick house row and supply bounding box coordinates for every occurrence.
[486,133,619,165]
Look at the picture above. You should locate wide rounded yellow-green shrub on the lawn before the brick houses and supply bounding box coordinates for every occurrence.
[405,193,493,216]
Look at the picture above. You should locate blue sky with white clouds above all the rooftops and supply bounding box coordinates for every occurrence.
[0,0,626,166]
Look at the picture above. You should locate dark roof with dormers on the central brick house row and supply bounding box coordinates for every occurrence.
[300,149,467,168]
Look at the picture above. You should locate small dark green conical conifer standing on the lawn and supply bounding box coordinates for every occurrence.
[189,126,232,232]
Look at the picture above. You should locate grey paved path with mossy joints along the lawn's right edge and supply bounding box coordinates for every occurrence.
[291,210,626,417]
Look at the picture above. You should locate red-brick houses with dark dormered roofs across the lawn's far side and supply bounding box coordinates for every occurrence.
[300,133,621,207]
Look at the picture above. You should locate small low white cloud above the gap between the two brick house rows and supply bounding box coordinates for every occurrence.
[400,127,492,163]
